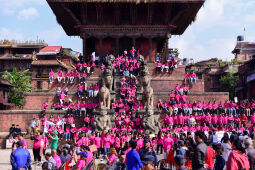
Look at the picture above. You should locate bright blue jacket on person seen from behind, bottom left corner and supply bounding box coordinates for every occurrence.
[11,147,31,170]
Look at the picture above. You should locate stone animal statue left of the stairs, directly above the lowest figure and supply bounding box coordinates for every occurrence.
[99,84,111,109]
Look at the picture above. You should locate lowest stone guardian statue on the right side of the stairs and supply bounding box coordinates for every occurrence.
[143,106,160,134]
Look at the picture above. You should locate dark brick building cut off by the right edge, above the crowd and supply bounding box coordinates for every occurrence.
[236,58,255,99]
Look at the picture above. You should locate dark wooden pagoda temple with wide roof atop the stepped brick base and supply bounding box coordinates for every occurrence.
[47,0,205,61]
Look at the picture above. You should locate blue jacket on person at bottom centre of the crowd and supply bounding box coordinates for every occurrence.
[127,149,143,170]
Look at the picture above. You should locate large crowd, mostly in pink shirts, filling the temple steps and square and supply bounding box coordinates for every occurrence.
[10,47,255,170]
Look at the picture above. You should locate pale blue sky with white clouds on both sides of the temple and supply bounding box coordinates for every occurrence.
[0,0,255,61]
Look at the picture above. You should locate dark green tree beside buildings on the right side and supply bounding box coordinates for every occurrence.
[220,73,238,100]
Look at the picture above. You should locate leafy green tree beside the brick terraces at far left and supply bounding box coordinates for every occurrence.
[2,67,32,106]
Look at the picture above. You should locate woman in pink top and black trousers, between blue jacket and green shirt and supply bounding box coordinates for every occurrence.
[31,131,42,162]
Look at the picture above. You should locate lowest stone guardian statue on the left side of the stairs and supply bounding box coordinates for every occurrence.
[95,107,112,131]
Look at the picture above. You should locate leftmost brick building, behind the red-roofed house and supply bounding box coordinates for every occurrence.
[0,40,47,72]
